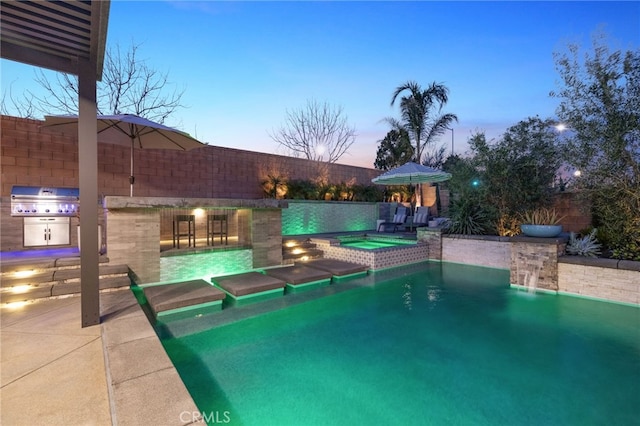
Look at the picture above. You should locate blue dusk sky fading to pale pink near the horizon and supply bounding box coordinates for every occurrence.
[1,0,640,167]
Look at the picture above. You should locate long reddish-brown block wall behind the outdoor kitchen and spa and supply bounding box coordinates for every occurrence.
[0,115,380,199]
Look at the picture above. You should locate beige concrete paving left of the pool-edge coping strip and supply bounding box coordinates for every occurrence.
[0,297,112,426]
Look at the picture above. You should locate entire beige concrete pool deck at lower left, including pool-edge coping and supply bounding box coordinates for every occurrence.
[0,290,201,425]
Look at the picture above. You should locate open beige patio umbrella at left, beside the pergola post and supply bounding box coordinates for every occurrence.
[42,114,205,196]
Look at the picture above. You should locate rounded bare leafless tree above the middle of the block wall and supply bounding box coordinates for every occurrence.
[270,100,356,163]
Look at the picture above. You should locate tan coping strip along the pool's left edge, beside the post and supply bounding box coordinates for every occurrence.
[100,290,204,425]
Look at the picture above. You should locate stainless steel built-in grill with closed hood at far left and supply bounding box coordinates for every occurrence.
[11,186,80,217]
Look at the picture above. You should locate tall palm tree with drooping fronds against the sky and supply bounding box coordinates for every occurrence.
[387,81,458,163]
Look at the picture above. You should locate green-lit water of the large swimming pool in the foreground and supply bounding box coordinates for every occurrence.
[161,263,640,425]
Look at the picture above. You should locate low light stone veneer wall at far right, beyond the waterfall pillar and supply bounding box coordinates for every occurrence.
[558,256,640,305]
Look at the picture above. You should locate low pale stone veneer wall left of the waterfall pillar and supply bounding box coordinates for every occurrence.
[440,235,511,269]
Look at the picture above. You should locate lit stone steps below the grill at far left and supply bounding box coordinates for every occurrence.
[0,256,131,303]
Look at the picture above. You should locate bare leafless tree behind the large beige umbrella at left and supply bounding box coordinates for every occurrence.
[31,45,184,123]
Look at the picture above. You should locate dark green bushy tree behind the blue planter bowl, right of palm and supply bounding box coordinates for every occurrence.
[443,117,561,235]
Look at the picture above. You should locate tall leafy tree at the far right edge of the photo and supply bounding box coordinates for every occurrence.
[551,33,640,260]
